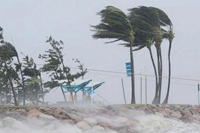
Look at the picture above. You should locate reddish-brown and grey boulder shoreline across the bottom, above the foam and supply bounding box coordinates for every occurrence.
[0,104,200,133]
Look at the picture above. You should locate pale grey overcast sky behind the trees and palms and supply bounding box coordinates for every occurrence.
[0,0,200,104]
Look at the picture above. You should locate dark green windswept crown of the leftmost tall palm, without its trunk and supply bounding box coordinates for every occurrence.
[91,6,133,43]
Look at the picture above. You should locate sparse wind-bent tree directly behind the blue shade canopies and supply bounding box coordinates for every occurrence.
[39,36,86,101]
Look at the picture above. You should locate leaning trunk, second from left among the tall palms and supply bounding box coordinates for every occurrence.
[148,48,158,104]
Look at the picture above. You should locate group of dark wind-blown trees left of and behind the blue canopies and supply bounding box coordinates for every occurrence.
[0,27,87,106]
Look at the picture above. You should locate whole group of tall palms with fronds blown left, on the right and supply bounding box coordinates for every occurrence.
[92,6,174,104]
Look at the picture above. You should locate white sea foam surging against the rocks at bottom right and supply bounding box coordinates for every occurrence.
[135,115,200,133]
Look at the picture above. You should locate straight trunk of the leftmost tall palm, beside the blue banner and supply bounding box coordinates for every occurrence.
[130,44,136,104]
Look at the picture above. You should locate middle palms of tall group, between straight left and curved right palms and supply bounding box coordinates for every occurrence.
[129,6,162,103]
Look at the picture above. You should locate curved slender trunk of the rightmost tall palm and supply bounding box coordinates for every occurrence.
[163,40,172,104]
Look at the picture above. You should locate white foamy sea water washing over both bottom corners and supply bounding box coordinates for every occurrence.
[0,111,200,133]
